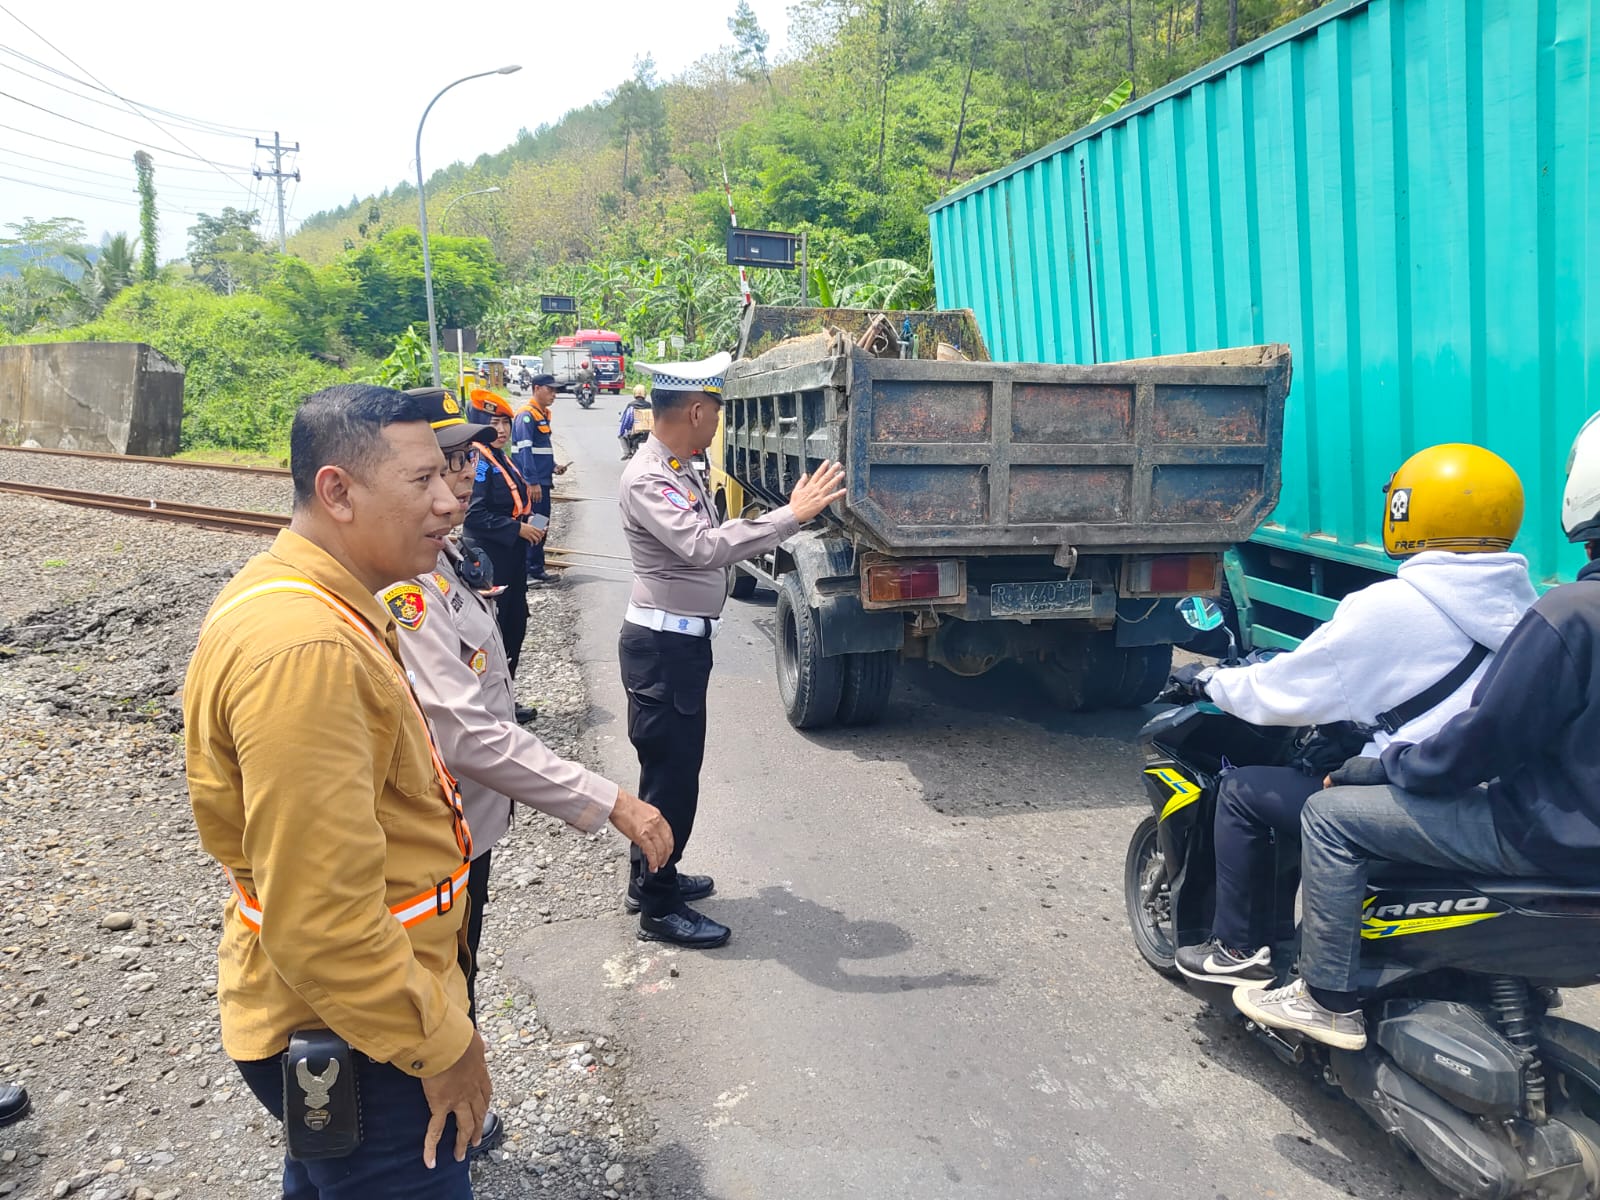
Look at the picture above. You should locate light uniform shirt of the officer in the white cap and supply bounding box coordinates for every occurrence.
[619,434,800,616]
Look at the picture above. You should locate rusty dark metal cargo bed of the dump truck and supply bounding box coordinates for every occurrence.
[723,333,1291,555]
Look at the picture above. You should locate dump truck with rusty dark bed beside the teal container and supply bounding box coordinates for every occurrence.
[710,307,1291,728]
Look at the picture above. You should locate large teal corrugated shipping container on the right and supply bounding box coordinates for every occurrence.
[928,0,1600,645]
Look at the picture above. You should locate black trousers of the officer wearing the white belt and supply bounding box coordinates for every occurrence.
[618,622,710,917]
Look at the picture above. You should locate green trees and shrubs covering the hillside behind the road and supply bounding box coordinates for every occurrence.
[0,0,1320,456]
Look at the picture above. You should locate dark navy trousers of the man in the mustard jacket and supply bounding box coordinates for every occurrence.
[235,1054,472,1200]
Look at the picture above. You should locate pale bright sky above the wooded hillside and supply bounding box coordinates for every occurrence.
[0,0,789,262]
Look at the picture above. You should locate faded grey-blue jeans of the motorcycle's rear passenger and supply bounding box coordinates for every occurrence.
[1299,787,1544,992]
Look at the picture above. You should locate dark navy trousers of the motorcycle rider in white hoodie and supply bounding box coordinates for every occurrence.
[1211,766,1322,954]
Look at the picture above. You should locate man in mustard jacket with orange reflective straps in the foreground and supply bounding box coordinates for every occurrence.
[184,384,491,1200]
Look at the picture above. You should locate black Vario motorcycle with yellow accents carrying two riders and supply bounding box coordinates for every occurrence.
[1123,598,1600,1200]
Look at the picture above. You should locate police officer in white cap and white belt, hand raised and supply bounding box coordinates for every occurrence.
[618,354,845,949]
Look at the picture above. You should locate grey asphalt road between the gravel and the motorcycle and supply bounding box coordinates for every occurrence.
[507,397,1465,1200]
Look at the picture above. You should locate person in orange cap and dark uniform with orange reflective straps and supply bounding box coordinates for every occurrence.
[466,395,544,691]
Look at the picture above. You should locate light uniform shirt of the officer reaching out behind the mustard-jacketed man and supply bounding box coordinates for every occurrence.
[378,550,616,856]
